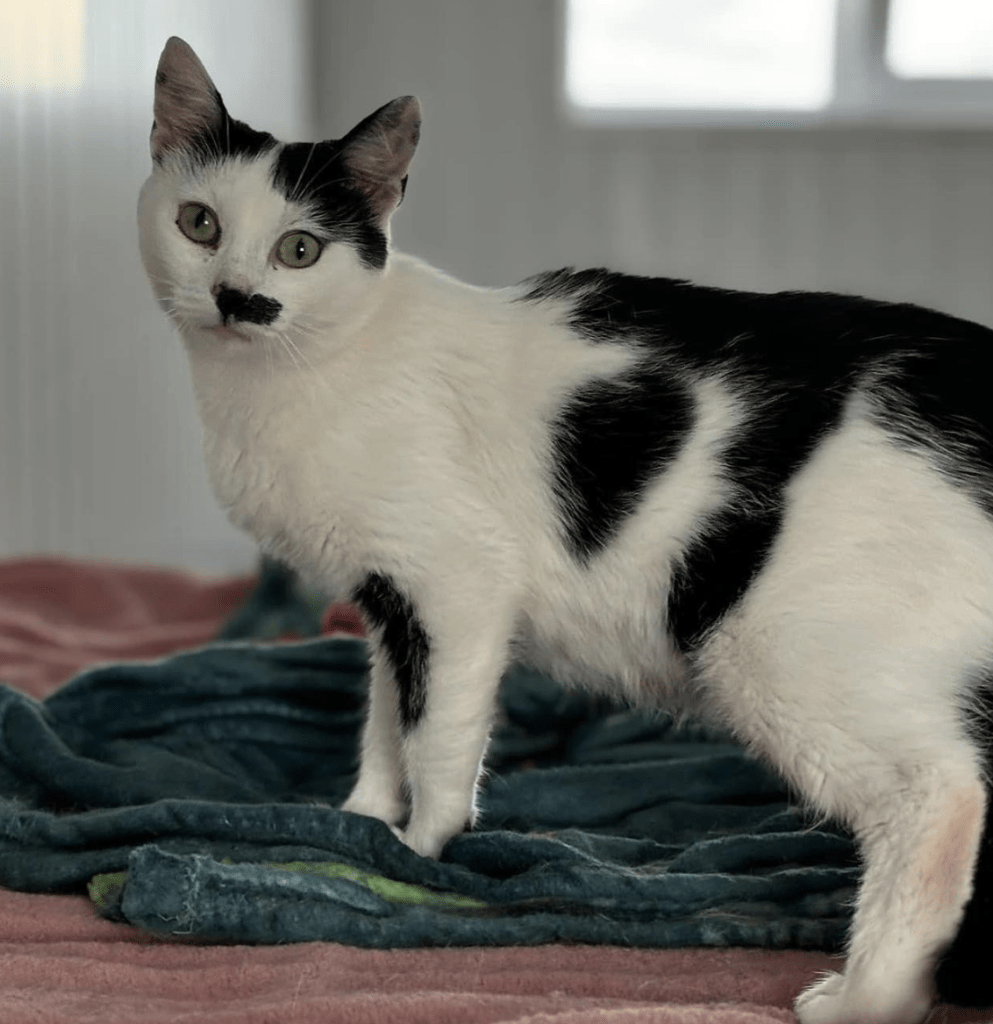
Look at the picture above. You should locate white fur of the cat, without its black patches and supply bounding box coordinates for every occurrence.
[139,136,993,1024]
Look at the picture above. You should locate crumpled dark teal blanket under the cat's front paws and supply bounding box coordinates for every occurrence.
[0,640,858,949]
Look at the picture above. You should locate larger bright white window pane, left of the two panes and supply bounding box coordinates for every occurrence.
[565,0,835,111]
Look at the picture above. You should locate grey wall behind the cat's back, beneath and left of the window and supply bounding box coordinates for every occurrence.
[315,0,993,324]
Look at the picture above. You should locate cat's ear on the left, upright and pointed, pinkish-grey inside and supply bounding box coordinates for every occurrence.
[152,36,225,163]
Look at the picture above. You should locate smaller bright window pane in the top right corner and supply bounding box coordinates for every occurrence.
[887,0,993,78]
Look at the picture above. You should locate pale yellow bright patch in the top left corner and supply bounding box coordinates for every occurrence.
[0,0,85,89]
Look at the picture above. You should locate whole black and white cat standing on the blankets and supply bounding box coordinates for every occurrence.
[139,39,993,1024]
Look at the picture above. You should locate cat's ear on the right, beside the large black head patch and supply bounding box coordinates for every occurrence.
[341,96,421,223]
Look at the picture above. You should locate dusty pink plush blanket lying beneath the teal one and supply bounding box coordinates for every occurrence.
[0,558,993,1024]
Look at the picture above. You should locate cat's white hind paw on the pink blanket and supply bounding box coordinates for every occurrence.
[793,973,933,1024]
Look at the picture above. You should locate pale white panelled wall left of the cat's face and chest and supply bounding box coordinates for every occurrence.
[0,0,310,570]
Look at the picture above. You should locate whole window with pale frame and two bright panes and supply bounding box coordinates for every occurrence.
[563,0,993,127]
